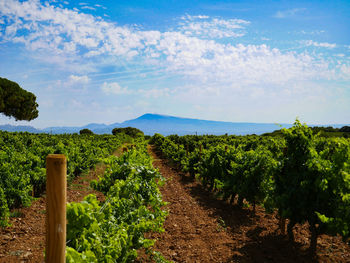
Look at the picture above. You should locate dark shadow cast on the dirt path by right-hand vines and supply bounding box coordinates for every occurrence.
[152,148,318,263]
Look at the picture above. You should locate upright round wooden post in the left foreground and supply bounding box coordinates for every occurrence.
[45,154,67,263]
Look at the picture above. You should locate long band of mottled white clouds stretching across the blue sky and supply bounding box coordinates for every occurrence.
[0,0,344,94]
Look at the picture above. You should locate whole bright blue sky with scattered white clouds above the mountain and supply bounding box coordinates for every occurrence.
[0,0,350,128]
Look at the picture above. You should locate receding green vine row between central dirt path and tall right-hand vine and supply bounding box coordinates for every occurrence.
[150,134,283,209]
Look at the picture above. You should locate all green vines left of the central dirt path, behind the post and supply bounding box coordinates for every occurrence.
[0,132,166,262]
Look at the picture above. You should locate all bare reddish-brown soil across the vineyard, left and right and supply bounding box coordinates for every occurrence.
[0,146,350,263]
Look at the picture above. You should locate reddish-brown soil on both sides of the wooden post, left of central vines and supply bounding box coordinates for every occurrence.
[0,165,104,263]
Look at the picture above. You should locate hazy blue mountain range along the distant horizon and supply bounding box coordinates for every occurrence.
[0,113,344,135]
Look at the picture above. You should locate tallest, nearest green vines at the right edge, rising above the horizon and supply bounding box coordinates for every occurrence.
[275,121,350,250]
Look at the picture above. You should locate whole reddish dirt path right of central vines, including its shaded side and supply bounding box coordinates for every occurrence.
[149,147,350,263]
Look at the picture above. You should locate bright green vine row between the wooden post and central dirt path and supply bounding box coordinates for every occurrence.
[66,142,167,262]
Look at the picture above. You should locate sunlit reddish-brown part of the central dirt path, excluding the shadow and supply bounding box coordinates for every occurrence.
[150,146,235,262]
